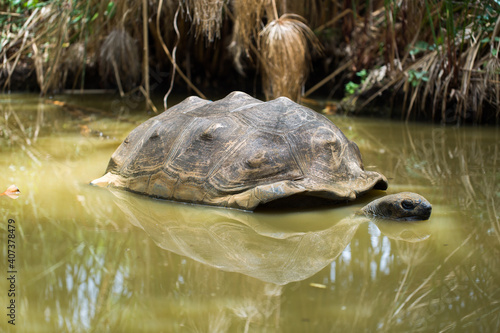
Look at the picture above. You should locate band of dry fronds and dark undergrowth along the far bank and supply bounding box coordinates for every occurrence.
[0,0,500,124]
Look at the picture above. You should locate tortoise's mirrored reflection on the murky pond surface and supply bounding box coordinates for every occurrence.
[109,188,430,285]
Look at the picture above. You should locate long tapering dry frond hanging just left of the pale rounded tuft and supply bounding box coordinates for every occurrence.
[229,0,265,75]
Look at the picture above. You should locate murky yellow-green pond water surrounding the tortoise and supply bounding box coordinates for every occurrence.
[0,95,500,332]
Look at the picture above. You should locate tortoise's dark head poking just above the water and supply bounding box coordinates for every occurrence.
[361,192,432,221]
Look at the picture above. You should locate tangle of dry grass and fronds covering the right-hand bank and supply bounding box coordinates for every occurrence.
[345,0,500,124]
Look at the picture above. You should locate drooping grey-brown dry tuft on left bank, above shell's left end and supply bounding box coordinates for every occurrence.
[99,28,141,93]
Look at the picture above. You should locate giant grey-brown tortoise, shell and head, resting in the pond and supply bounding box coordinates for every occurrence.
[91,92,431,219]
